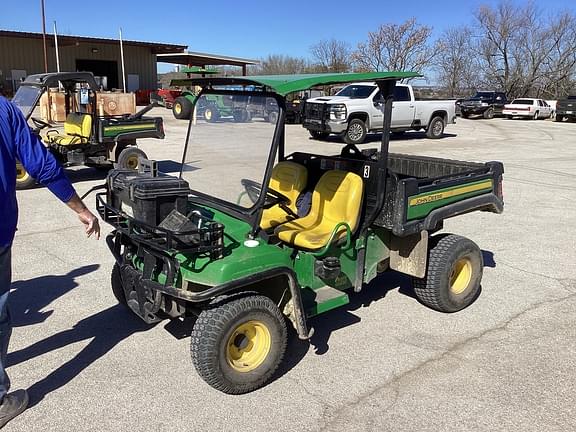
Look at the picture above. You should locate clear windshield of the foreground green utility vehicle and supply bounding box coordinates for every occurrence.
[182,93,279,208]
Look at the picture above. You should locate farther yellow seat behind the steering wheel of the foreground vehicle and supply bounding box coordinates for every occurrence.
[260,161,308,230]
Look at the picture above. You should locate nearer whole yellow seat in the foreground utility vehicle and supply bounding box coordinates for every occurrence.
[276,170,364,250]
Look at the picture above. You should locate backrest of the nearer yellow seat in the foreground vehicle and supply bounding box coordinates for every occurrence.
[310,170,364,231]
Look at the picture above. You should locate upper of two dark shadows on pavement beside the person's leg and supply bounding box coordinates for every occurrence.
[9,264,100,327]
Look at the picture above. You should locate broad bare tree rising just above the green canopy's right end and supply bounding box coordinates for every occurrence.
[352,18,436,76]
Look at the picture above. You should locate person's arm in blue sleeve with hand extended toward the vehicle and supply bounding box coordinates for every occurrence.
[9,99,100,239]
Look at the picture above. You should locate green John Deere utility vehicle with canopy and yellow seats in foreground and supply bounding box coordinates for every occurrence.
[97,72,503,394]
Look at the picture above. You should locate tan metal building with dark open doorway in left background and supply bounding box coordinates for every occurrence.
[0,30,187,95]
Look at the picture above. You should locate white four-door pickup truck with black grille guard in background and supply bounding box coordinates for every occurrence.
[302,82,456,144]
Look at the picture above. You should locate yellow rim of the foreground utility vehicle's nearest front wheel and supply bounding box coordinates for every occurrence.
[226,320,272,372]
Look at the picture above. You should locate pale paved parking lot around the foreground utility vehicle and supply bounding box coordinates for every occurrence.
[5,109,576,432]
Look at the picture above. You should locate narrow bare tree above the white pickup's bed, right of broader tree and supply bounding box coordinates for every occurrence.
[434,27,480,97]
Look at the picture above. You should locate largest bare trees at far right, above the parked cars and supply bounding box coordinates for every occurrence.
[475,0,576,97]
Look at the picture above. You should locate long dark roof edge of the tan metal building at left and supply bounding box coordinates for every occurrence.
[0,30,188,54]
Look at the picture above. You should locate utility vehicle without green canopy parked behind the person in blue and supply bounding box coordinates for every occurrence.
[12,72,164,189]
